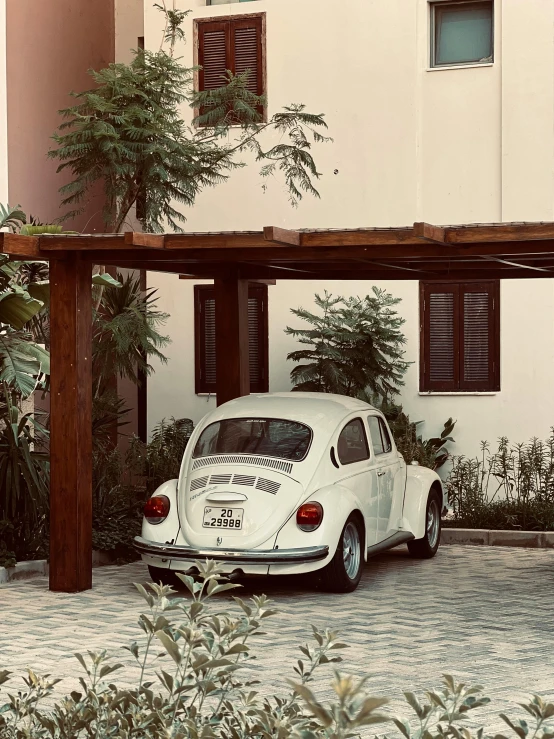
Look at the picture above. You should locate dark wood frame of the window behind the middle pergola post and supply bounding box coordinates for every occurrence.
[194,282,269,395]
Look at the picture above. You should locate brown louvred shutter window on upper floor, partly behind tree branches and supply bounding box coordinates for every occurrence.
[197,15,265,120]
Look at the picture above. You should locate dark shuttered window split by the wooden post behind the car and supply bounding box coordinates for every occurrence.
[194,285,269,394]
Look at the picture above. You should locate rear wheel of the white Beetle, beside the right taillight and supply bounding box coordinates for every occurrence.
[322,517,364,593]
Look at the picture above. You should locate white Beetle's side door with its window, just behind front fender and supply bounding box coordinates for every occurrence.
[367,415,403,543]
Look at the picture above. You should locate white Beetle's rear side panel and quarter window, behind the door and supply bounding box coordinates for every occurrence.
[337,418,379,547]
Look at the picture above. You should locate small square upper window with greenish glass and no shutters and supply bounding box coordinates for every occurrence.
[431,0,493,67]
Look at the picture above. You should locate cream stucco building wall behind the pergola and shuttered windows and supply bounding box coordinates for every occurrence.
[145,0,554,454]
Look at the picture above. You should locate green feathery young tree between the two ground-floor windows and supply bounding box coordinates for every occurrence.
[285,287,409,403]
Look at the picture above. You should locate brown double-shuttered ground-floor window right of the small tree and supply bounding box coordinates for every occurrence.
[420,281,500,392]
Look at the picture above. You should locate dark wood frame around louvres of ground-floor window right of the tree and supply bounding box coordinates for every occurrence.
[419,280,501,394]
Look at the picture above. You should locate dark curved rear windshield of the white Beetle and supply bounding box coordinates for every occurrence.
[192,418,312,462]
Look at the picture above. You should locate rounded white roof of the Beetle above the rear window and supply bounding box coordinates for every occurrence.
[209,392,373,427]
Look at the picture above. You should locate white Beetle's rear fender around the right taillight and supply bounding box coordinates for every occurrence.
[275,485,367,566]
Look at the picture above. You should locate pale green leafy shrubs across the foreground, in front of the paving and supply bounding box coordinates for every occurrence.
[0,562,554,739]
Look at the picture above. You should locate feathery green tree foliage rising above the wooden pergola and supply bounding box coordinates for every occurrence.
[49,3,329,232]
